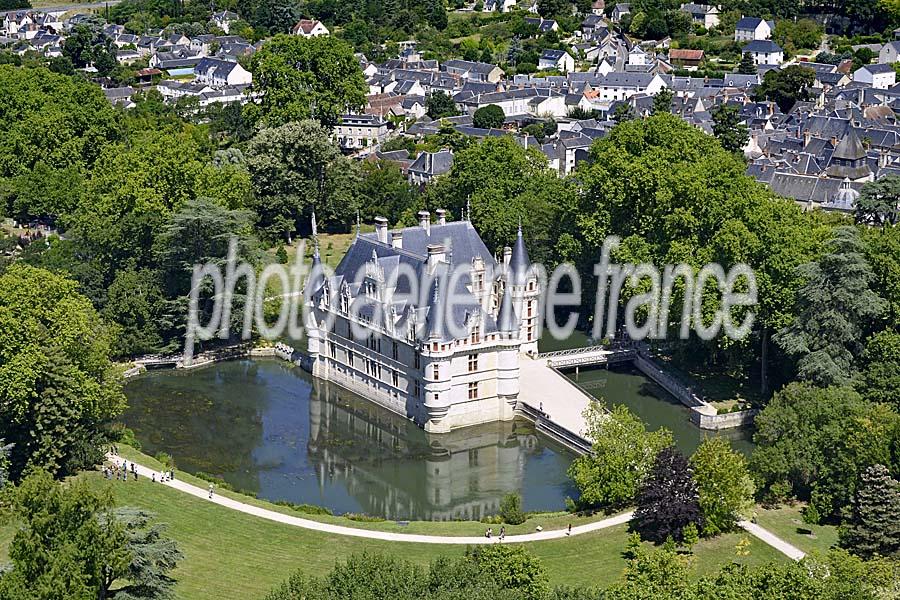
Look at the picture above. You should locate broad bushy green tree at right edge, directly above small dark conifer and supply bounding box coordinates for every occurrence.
[744,383,900,520]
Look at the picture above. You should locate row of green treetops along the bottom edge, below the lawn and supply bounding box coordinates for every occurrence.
[266,544,897,600]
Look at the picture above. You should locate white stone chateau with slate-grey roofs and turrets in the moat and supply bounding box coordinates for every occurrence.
[304,210,540,433]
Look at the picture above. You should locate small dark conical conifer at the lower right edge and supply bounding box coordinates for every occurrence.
[840,465,900,558]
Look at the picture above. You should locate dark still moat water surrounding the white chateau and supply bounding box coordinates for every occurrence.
[125,360,750,520]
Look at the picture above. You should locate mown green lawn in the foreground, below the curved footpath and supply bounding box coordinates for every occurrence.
[0,464,786,600]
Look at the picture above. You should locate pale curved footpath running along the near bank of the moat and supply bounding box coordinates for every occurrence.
[108,455,805,560]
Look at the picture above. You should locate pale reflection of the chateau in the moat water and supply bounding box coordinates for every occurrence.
[307,380,545,520]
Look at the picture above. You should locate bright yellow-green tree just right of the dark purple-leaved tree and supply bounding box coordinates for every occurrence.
[690,437,754,536]
